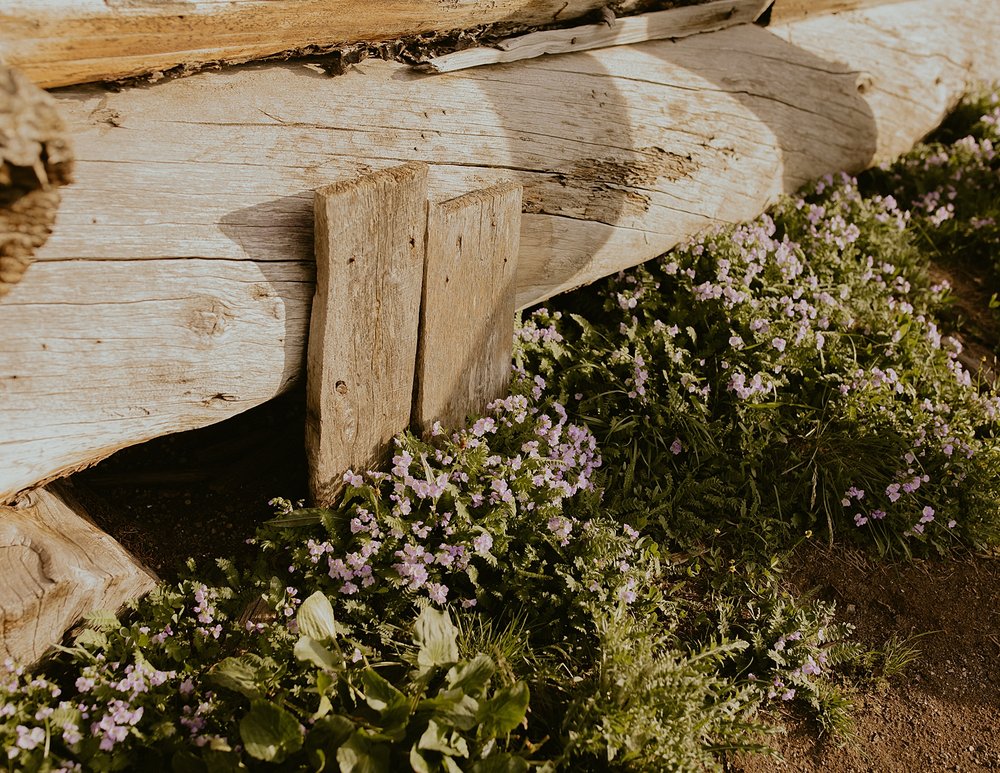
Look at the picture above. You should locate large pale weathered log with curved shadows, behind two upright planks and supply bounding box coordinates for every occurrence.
[0,0,1000,501]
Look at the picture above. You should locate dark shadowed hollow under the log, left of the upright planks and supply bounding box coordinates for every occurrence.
[70,392,307,580]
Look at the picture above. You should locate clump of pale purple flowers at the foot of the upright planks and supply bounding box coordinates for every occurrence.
[286,374,601,607]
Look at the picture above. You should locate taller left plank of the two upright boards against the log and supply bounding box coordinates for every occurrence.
[306,163,428,505]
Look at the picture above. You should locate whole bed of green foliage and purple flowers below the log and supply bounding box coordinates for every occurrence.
[0,89,1000,771]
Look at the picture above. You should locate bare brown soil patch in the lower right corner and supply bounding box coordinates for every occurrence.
[728,549,1000,773]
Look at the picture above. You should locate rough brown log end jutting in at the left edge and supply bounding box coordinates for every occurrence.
[0,65,73,298]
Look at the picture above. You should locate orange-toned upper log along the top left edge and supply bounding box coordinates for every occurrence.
[0,0,637,88]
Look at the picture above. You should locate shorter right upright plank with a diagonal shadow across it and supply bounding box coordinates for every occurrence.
[414,183,521,430]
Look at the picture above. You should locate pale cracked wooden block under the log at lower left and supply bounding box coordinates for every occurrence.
[0,489,157,663]
